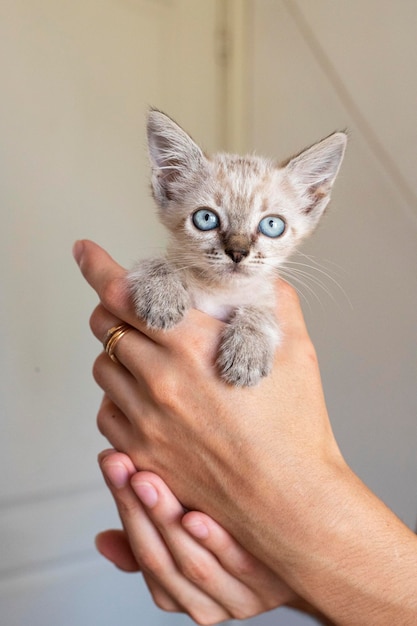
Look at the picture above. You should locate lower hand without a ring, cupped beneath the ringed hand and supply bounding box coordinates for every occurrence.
[96,450,296,624]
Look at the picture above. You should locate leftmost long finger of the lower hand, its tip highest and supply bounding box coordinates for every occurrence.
[101,453,230,623]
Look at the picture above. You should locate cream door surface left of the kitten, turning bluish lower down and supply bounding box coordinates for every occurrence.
[0,0,228,626]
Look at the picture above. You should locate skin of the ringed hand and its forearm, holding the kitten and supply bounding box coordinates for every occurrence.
[74,242,417,626]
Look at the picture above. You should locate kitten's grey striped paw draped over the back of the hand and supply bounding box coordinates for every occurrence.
[217,311,278,387]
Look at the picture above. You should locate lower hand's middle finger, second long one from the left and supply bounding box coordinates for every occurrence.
[131,472,281,619]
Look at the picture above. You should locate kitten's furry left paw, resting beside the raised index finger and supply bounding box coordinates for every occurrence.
[128,259,191,330]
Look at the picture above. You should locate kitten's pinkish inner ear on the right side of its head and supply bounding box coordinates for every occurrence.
[286,133,347,221]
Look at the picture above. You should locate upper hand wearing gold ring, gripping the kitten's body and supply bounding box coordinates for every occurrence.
[74,242,342,559]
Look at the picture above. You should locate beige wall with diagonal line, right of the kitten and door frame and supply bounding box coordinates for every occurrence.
[245,0,417,626]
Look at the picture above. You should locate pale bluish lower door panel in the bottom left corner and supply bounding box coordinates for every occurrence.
[0,558,193,626]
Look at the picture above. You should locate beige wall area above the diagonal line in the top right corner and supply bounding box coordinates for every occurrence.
[286,0,417,212]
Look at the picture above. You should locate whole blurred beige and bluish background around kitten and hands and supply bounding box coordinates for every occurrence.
[0,0,417,626]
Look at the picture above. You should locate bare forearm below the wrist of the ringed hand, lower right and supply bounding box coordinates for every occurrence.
[231,454,417,626]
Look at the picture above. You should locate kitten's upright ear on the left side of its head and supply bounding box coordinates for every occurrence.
[147,110,205,204]
